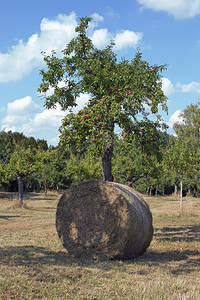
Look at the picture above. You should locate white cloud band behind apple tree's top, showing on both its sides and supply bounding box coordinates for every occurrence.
[0,12,143,83]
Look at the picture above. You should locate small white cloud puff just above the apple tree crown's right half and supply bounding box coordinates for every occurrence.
[114,30,143,50]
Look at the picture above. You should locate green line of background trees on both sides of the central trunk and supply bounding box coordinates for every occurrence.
[0,103,200,202]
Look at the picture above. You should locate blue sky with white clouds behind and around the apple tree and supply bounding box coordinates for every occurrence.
[0,0,200,145]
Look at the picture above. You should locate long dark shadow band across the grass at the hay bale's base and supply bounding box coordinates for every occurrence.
[0,246,200,275]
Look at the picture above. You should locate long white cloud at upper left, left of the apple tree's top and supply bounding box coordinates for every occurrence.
[0,12,77,83]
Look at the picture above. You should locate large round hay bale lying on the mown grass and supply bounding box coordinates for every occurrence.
[56,180,153,259]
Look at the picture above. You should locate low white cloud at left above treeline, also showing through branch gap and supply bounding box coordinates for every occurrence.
[2,94,90,145]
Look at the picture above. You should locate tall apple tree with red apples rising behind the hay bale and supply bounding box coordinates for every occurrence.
[38,17,167,181]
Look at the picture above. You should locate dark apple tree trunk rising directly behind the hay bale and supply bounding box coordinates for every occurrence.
[102,142,114,181]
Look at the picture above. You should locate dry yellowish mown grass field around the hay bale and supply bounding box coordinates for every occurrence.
[0,194,200,300]
